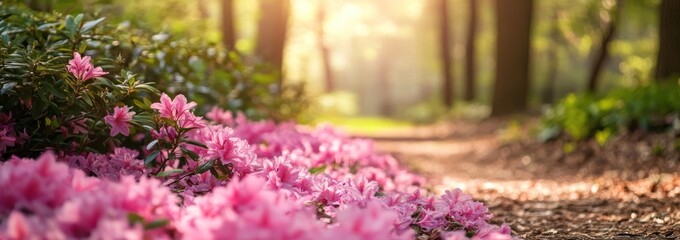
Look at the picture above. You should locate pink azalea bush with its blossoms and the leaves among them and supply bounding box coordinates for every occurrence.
[0,52,511,239]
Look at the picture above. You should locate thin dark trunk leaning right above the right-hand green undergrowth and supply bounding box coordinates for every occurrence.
[586,0,623,92]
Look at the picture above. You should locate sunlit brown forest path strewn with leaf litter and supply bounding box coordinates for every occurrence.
[364,117,680,239]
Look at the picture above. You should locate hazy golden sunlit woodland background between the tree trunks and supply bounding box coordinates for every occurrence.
[50,0,659,125]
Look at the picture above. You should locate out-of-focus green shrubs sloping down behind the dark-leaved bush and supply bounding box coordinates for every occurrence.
[0,2,307,120]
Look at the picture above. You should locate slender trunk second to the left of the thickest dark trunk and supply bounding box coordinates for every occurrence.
[439,0,454,108]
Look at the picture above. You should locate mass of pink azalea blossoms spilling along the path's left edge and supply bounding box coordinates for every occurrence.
[0,94,512,239]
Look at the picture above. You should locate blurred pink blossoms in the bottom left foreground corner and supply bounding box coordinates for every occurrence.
[0,152,180,239]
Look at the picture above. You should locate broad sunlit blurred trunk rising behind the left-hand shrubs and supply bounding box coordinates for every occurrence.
[255,0,290,80]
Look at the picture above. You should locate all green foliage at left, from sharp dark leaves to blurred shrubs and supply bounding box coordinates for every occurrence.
[0,3,305,157]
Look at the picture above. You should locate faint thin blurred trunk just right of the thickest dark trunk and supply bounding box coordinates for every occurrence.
[543,10,560,103]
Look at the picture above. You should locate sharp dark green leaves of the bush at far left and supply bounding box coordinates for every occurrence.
[0,4,158,157]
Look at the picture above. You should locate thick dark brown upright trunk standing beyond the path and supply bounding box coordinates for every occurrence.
[491,0,533,116]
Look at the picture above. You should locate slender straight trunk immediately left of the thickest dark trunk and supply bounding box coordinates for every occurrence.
[464,0,477,101]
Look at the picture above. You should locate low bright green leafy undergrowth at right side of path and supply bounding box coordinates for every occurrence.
[539,82,680,142]
